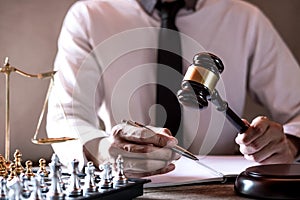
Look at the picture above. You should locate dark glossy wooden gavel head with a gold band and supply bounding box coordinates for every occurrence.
[177,52,224,109]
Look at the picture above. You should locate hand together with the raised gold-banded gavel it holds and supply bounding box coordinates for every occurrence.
[177,53,299,164]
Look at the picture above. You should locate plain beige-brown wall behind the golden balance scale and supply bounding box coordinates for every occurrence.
[0,0,75,161]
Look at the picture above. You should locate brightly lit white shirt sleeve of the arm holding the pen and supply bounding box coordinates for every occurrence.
[47,3,107,165]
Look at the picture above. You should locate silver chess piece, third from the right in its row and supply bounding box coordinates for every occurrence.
[84,161,98,195]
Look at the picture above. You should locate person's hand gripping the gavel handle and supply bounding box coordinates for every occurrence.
[235,116,297,164]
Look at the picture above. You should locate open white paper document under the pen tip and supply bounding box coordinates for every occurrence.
[145,156,259,188]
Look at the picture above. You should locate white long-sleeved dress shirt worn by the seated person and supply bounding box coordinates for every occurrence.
[47,0,300,166]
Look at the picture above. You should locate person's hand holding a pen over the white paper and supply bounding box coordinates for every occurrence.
[108,124,179,177]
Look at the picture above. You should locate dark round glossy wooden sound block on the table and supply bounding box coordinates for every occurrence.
[234,164,300,199]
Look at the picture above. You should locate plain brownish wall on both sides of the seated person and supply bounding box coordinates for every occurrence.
[0,0,300,161]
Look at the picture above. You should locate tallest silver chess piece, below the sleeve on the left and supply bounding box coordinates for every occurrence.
[47,154,65,200]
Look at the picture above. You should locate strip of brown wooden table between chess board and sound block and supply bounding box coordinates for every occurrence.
[136,183,250,200]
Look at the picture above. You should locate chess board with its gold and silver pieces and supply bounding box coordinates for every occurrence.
[0,150,150,200]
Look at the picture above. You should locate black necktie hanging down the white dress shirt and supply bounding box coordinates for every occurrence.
[156,0,185,135]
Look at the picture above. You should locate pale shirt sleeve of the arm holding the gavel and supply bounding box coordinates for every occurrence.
[248,8,300,137]
